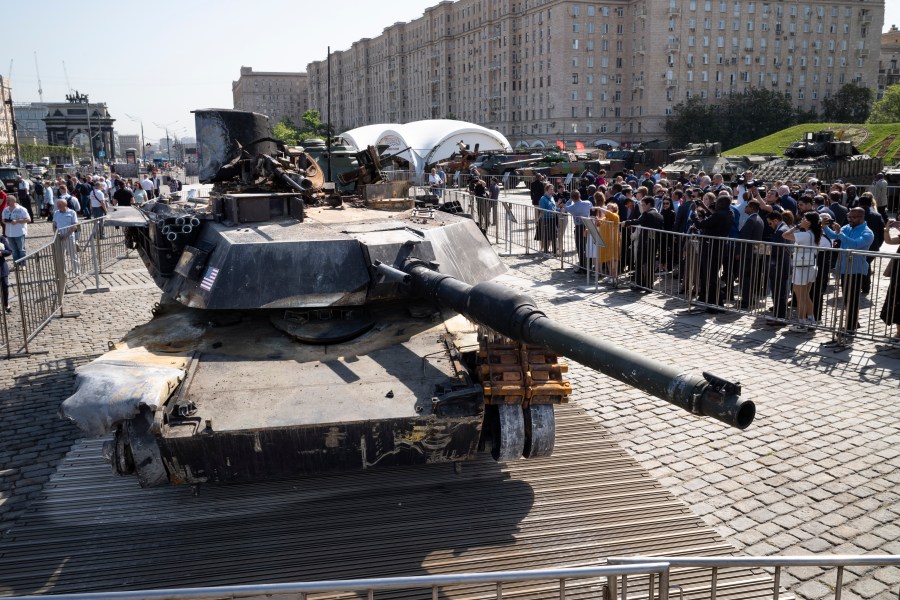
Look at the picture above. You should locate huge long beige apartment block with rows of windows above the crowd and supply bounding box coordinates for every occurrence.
[307,0,884,147]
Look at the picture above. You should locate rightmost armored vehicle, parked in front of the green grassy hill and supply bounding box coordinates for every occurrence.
[754,130,882,185]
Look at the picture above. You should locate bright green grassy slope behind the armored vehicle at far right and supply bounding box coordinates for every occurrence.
[723,123,900,165]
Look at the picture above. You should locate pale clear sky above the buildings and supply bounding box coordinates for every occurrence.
[0,0,900,139]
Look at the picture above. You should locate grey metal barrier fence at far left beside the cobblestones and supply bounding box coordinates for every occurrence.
[0,217,125,358]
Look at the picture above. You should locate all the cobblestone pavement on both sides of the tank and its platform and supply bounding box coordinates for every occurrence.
[0,227,900,600]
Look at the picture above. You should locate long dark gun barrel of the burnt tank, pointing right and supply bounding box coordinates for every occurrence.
[377,260,756,429]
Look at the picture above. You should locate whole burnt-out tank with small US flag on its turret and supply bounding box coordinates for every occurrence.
[61,111,755,487]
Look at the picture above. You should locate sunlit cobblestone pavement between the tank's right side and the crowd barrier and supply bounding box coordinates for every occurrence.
[507,256,900,600]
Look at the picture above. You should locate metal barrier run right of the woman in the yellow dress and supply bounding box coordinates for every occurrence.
[620,228,900,347]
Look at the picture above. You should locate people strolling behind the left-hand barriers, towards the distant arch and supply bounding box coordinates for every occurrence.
[0,170,181,312]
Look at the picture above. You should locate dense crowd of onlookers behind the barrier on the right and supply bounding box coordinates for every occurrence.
[530,170,900,344]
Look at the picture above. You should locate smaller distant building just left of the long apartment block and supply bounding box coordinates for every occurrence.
[231,67,309,125]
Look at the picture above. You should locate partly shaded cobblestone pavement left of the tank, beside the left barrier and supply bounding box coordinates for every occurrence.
[0,223,159,533]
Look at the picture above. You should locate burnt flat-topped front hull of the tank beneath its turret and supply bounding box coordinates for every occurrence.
[92,303,485,487]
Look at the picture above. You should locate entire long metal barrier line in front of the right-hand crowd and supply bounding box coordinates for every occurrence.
[443,190,900,348]
